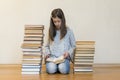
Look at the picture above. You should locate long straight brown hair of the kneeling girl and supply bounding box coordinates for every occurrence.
[49,8,67,41]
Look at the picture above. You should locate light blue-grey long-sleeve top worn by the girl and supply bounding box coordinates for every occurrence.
[45,28,76,60]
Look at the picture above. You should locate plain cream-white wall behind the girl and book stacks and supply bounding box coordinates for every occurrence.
[0,0,120,64]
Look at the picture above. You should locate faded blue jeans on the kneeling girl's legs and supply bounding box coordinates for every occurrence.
[46,59,70,74]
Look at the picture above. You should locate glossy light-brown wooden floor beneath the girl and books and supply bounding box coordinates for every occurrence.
[0,65,120,80]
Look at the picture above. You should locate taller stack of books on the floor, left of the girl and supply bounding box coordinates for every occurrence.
[21,25,44,74]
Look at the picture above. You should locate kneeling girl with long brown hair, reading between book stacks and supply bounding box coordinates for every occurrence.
[45,8,75,74]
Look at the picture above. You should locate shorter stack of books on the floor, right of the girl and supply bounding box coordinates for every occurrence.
[73,41,95,72]
